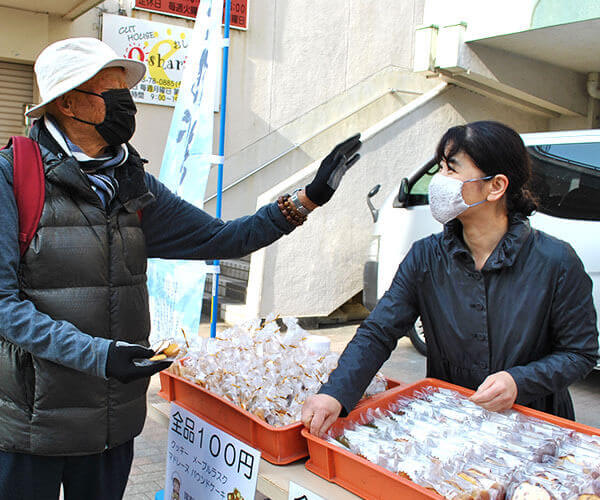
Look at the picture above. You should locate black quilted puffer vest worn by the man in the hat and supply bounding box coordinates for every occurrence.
[0,120,157,455]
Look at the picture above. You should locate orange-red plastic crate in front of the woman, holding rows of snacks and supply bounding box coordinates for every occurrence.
[302,378,600,500]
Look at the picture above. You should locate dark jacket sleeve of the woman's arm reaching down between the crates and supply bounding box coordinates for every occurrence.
[319,240,424,416]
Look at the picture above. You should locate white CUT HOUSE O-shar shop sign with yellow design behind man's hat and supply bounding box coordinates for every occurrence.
[102,14,192,106]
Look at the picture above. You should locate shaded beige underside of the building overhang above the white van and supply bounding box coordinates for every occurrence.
[468,18,600,73]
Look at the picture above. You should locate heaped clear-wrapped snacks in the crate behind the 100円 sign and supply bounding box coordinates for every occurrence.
[171,315,387,427]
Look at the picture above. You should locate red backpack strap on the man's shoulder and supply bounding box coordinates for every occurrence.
[7,136,46,257]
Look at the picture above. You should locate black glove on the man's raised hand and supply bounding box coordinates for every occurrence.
[306,134,362,205]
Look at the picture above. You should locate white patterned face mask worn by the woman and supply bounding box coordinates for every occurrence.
[429,173,494,224]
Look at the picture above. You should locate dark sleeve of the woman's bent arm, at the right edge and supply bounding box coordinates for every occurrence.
[507,245,598,404]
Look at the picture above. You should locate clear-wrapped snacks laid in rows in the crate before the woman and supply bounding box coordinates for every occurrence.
[327,387,600,500]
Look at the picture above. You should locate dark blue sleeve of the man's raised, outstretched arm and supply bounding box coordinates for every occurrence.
[142,174,294,260]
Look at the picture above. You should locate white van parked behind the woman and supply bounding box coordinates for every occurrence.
[363,130,600,362]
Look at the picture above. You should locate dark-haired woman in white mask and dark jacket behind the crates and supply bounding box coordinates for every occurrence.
[302,121,598,435]
